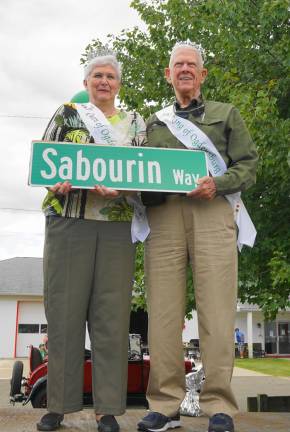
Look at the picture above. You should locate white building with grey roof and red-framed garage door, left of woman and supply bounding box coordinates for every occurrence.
[0,258,47,358]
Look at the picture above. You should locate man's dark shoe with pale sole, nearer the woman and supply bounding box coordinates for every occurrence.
[137,411,181,432]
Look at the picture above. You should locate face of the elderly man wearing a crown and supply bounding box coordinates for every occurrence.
[165,47,207,99]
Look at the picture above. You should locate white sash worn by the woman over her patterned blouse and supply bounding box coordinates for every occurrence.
[75,102,150,243]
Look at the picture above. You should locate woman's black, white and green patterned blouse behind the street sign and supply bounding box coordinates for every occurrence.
[42,103,146,221]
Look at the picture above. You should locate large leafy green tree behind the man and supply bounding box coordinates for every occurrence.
[82,0,290,319]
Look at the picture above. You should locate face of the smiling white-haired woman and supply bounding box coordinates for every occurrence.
[84,65,121,104]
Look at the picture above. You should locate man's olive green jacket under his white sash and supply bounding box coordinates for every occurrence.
[146,101,258,195]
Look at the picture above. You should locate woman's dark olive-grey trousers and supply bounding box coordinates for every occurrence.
[44,217,135,415]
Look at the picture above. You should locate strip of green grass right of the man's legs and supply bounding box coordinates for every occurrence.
[235,358,290,377]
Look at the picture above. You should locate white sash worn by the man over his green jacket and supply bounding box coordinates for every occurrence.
[156,105,257,251]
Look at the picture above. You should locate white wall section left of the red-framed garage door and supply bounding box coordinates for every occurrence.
[0,298,17,359]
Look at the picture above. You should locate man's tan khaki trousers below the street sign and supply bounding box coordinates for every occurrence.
[145,195,238,416]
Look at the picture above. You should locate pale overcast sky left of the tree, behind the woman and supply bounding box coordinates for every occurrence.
[0,0,144,260]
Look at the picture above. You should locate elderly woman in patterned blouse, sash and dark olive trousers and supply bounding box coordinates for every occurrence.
[37,53,145,432]
